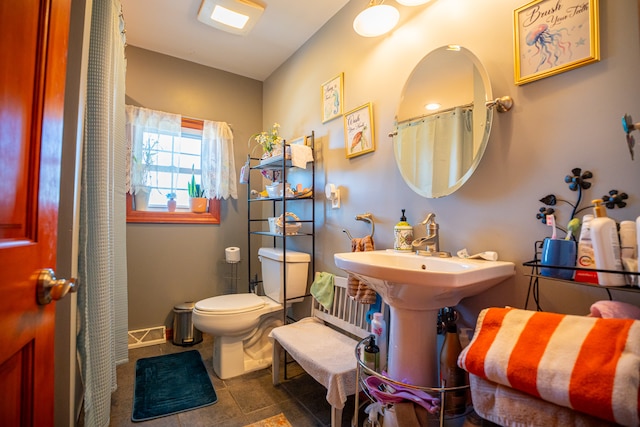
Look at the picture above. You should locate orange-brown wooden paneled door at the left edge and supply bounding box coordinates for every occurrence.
[0,0,70,427]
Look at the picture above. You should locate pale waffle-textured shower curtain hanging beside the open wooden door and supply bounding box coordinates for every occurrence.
[78,0,128,427]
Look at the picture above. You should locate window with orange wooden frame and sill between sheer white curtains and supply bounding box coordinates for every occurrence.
[127,118,220,224]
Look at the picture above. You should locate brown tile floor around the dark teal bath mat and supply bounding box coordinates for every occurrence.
[110,335,354,427]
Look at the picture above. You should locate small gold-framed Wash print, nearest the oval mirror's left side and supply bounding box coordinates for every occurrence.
[344,102,376,158]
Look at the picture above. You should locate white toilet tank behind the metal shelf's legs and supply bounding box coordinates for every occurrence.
[258,248,311,303]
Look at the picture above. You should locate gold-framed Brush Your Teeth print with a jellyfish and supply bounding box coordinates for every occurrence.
[513,0,600,85]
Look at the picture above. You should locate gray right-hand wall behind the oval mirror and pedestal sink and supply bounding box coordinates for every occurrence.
[263,0,640,332]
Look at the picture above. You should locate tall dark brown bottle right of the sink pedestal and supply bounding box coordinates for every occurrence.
[440,317,467,415]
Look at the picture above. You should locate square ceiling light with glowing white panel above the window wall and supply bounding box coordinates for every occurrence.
[198,0,264,35]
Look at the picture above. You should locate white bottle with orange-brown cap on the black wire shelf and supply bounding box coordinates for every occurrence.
[591,199,627,286]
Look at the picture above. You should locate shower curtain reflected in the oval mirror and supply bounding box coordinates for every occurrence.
[396,107,473,195]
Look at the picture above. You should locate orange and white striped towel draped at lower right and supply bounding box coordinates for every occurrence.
[458,308,640,426]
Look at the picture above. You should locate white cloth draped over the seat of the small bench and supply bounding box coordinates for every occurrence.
[269,317,358,409]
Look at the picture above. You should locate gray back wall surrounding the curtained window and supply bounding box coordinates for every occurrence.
[126,46,262,330]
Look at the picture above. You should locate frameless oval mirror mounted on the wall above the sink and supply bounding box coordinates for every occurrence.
[393,45,493,198]
